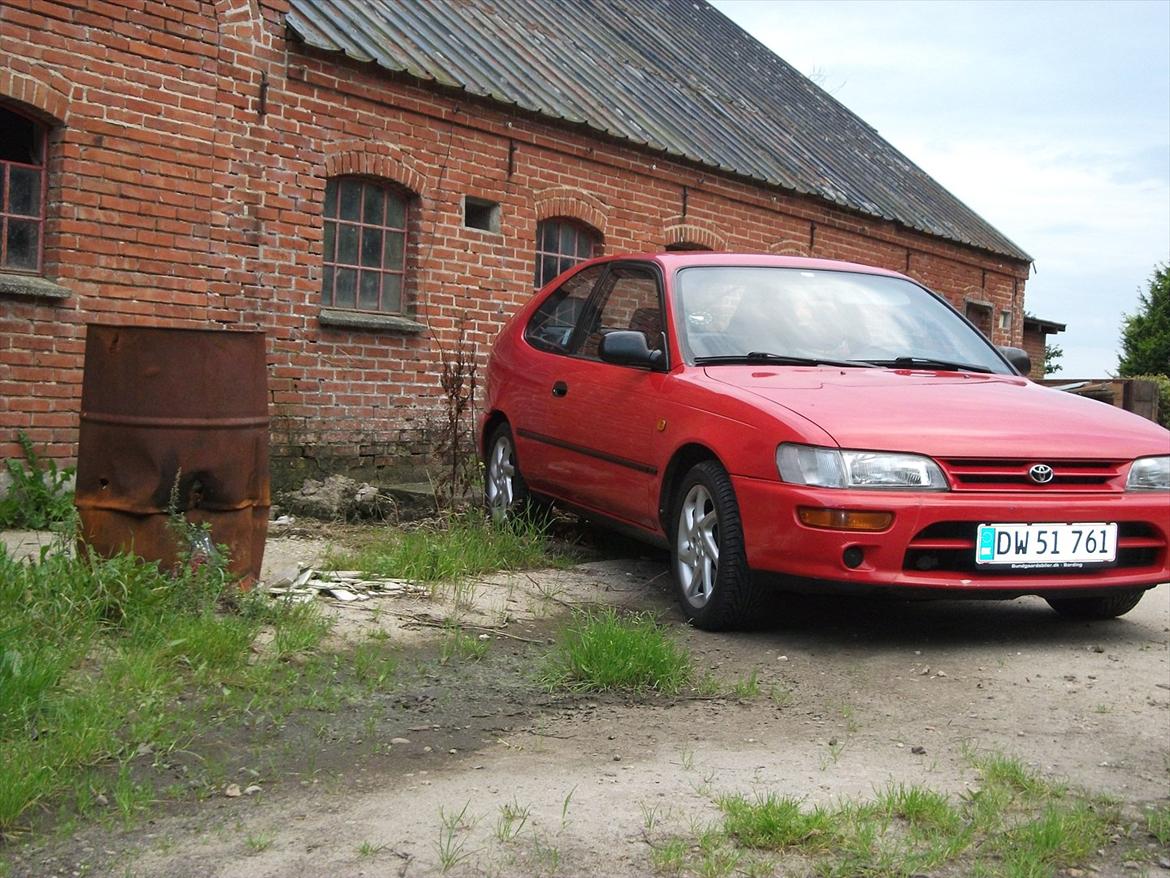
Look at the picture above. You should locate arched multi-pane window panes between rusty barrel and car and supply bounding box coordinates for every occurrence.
[321,177,410,314]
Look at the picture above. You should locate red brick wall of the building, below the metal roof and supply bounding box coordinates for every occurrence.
[0,0,1027,482]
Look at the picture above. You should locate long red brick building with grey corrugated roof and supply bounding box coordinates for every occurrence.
[0,0,1031,485]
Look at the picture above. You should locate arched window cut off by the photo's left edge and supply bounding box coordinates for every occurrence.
[0,108,48,274]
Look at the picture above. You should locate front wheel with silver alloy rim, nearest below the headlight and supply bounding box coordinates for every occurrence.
[670,460,762,631]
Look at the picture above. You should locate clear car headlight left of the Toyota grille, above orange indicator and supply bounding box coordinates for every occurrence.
[776,443,948,491]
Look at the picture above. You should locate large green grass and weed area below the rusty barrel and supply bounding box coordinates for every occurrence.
[0,536,326,838]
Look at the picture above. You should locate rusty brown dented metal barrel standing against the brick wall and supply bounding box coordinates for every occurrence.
[76,323,270,588]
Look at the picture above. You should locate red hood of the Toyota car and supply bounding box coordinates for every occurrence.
[706,365,1170,459]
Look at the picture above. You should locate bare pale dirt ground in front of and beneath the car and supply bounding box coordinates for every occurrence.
[4,522,1170,878]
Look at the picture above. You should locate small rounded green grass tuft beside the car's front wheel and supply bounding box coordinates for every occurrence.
[539,608,694,694]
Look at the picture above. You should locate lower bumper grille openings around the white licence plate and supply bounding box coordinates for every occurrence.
[902,521,1166,576]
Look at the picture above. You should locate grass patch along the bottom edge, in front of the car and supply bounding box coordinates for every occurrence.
[644,754,1127,878]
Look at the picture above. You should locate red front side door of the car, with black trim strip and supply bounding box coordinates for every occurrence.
[535,262,669,527]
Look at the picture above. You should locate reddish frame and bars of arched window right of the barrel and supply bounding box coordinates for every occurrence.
[319,174,417,320]
